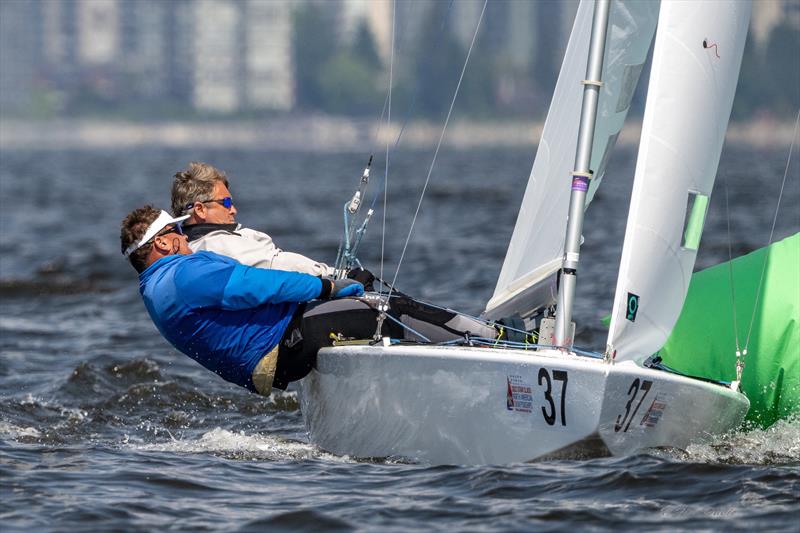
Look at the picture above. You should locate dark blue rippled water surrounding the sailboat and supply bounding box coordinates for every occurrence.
[0,143,800,531]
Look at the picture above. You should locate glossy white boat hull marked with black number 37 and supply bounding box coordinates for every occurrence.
[300,346,749,464]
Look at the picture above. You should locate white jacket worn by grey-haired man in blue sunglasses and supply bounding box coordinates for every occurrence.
[186,224,333,276]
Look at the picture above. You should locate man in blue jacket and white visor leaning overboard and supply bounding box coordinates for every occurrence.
[120,206,364,395]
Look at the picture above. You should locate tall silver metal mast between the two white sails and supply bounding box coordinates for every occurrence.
[554,0,610,348]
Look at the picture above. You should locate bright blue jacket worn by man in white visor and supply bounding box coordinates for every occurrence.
[139,252,322,391]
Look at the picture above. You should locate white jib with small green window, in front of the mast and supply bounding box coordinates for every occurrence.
[607,0,751,361]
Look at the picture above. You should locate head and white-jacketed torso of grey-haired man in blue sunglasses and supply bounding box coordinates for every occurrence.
[172,163,333,276]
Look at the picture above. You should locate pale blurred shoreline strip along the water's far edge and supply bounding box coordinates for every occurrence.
[0,116,794,153]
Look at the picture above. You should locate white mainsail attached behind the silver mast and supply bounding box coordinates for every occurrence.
[484,0,658,318]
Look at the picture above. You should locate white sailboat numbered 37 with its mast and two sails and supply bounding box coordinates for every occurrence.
[300,0,751,464]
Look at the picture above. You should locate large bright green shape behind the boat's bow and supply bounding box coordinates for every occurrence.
[659,233,800,427]
